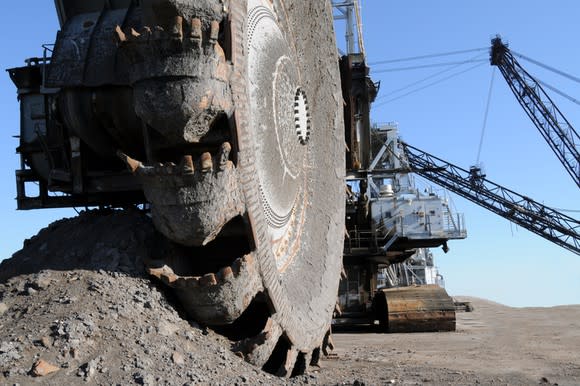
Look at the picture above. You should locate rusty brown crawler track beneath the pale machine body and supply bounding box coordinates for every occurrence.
[374,285,455,332]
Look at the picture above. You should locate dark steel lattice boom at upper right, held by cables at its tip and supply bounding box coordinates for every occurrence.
[490,37,580,187]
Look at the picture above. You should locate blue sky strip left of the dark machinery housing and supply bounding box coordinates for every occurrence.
[0,4,76,259]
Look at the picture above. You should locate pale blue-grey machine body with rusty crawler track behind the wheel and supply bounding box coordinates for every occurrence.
[334,53,466,332]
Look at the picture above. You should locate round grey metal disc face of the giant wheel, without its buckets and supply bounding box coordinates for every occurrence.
[232,0,344,370]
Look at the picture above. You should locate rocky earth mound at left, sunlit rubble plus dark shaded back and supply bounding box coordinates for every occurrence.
[0,211,328,385]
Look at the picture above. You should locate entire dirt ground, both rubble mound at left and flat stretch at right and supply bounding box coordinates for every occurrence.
[0,212,580,385]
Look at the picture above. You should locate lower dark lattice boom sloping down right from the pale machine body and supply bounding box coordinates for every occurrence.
[401,142,580,255]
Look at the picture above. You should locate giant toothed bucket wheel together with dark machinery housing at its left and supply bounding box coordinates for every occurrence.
[8,0,345,375]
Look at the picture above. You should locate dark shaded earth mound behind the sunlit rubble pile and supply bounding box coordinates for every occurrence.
[0,210,156,282]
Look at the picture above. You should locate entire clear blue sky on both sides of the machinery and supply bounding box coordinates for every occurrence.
[0,0,580,306]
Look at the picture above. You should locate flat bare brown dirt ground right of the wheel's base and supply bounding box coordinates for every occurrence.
[318,297,580,385]
